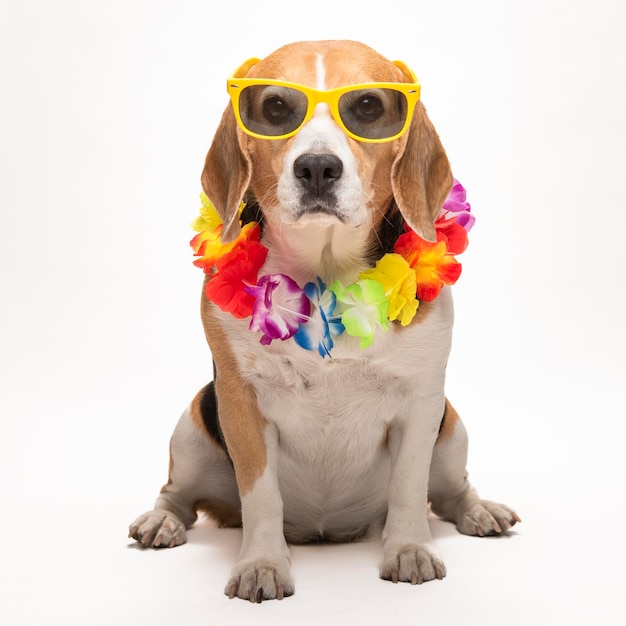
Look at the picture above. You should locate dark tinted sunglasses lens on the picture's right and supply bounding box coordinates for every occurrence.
[339,88,408,139]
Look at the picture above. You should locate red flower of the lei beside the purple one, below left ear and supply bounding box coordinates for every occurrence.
[205,240,267,319]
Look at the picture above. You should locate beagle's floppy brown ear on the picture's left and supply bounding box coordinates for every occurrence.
[201,105,252,243]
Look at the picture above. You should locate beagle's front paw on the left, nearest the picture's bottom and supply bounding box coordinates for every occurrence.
[224,559,295,602]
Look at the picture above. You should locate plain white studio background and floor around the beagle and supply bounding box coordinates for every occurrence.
[0,0,626,626]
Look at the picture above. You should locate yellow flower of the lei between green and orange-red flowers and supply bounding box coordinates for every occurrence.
[359,254,419,326]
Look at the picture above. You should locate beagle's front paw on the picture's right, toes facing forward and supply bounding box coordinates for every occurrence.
[380,544,446,585]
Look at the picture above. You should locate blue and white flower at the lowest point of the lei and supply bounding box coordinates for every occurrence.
[294,278,345,357]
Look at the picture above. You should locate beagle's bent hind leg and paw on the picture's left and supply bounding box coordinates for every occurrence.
[129,383,241,548]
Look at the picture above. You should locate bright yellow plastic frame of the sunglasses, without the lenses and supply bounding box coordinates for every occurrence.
[226,58,421,143]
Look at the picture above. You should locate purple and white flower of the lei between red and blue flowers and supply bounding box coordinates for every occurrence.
[244,274,311,345]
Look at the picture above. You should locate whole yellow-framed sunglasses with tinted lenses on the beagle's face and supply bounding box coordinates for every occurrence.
[226,59,420,143]
